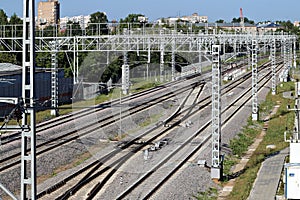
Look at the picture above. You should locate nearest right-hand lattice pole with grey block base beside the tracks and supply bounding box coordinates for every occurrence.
[211,45,222,179]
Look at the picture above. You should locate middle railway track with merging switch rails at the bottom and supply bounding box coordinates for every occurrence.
[39,59,280,199]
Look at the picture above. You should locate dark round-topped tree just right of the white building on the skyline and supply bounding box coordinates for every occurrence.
[87,12,108,35]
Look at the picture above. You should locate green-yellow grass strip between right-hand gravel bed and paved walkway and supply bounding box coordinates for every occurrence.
[225,83,295,200]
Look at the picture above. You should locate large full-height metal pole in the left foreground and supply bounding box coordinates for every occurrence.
[20,0,37,199]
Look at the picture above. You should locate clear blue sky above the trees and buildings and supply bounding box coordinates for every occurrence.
[0,0,300,22]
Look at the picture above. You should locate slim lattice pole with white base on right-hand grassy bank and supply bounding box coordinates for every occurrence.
[252,40,258,121]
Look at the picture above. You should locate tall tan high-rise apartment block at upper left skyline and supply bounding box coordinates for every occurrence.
[37,0,60,27]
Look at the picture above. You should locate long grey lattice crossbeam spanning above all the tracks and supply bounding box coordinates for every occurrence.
[0,33,296,53]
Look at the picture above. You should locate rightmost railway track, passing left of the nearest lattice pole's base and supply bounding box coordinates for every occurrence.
[113,63,282,200]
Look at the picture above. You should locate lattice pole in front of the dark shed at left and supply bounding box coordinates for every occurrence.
[51,40,58,116]
